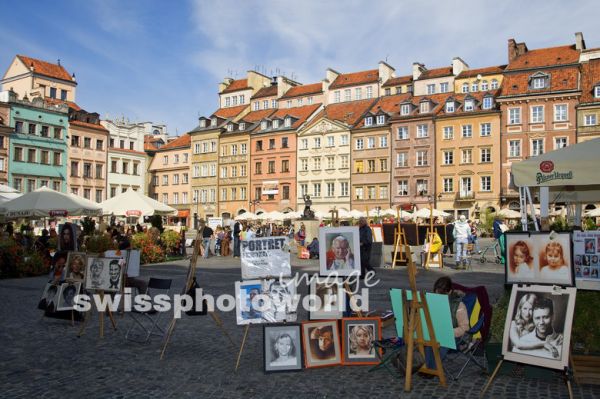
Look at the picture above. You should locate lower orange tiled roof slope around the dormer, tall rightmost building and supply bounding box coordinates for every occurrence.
[501,66,579,96]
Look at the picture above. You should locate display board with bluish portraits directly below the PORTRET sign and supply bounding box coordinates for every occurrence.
[235,279,297,325]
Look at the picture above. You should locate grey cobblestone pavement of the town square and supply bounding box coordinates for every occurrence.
[0,241,600,399]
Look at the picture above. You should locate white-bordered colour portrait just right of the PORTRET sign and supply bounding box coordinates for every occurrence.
[319,226,360,276]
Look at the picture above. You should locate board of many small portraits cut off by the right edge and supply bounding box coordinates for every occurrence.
[573,231,600,291]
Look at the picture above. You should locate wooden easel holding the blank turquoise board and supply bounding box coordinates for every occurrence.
[402,245,446,392]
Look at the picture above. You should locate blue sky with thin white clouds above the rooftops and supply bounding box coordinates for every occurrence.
[0,0,600,135]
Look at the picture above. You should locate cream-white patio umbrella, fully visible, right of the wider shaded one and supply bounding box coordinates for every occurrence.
[99,188,177,216]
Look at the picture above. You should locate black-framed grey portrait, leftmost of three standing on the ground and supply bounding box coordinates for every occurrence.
[263,324,303,373]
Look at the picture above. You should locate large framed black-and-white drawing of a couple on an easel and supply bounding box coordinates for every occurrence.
[502,285,577,369]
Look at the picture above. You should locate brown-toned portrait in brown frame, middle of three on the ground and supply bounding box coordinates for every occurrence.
[302,320,342,368]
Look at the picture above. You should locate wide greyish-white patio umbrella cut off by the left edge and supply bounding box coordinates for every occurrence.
[2,187,102,218]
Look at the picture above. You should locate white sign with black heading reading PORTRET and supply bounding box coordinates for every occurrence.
[241,237,292,279]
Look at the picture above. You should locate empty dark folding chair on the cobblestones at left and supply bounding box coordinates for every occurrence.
[125,278,172,343]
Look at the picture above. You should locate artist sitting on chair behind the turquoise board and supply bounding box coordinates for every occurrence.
[421,277,471,378]
